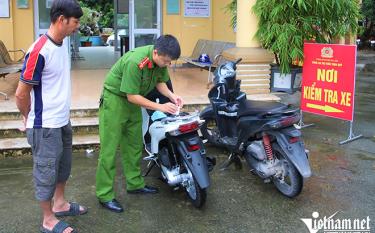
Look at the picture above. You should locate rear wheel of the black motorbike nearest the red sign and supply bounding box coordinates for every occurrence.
[273,143,303,198]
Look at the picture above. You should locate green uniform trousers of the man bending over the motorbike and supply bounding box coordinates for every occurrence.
[96,90,145,201]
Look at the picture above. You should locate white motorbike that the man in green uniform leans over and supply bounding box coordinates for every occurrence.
[142,109,214,208]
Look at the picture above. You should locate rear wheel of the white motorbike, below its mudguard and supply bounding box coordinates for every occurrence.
[184,163,207,208]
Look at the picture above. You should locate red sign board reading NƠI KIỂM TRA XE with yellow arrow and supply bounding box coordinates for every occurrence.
[301,43,357,121]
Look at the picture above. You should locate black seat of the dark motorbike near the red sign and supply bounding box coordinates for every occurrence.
[238,100,288,117]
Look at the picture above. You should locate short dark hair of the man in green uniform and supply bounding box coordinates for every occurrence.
[154,35,181,60]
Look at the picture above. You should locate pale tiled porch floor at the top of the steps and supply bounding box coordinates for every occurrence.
[0,47,212,111]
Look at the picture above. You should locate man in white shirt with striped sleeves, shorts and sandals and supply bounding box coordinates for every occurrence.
[16,0,87,233]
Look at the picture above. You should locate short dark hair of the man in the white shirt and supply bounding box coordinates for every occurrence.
[49,0,83,23]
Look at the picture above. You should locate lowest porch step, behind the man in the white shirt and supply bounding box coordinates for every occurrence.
[0,134,99,159]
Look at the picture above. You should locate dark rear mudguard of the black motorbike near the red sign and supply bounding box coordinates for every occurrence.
[269,131,312,178]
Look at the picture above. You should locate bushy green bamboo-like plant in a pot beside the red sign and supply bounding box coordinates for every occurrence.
[227,0,359,92]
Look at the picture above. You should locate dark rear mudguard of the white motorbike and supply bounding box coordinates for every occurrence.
[177,142,210,189]
